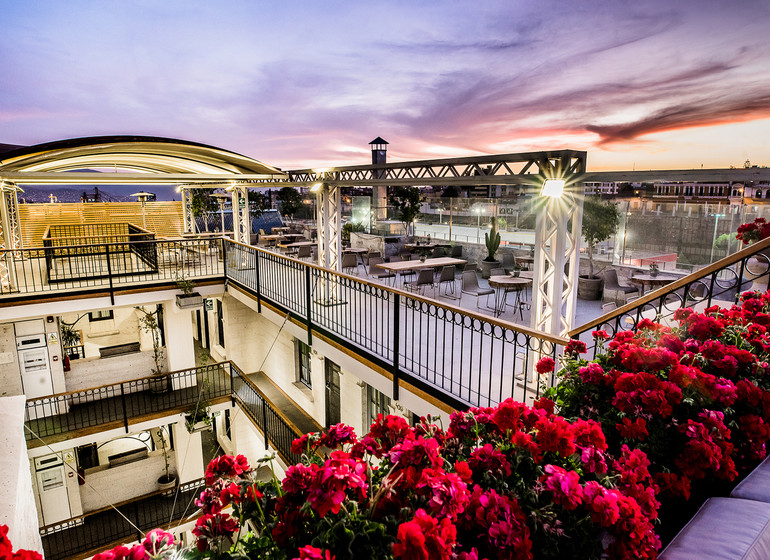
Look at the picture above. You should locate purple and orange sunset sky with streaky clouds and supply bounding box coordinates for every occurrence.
[0,0,770,170]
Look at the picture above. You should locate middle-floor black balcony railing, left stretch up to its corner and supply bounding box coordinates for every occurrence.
[24,362,231,441]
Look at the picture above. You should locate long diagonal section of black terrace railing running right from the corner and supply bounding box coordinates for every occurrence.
[225,241,567,408]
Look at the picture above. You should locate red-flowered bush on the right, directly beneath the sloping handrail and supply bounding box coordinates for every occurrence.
[548,293,770,516]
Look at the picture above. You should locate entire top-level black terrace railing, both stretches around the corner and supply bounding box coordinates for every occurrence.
[7,234,566,408]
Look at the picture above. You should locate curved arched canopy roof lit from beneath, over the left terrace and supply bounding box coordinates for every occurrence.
[0,136,284,184]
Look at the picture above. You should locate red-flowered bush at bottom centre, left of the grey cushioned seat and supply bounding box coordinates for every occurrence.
[96,402,659,560]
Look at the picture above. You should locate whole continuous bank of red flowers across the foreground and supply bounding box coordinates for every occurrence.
[87,293,770,560]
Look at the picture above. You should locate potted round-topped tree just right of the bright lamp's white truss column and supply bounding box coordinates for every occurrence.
[578,196,620,300]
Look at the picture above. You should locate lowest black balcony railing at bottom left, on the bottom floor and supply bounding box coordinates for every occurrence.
[40,479,205,560]
